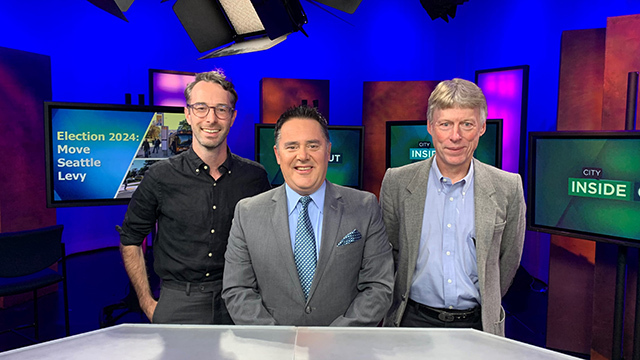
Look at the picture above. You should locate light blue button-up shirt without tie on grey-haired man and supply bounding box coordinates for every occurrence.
[410,159,481,310]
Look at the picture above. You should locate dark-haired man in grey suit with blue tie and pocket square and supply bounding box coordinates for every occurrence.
[222,106,393,326]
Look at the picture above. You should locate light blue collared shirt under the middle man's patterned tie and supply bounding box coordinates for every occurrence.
[284,181,327,258]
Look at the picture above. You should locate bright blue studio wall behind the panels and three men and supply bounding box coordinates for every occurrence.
[0,0,640,282]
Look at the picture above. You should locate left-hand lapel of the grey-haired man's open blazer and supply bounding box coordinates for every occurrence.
[403,157,433,281]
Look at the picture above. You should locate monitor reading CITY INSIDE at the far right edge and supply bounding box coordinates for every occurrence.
[527,131,640,247]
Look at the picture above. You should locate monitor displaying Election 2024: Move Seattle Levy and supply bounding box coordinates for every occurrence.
[44,102,191,207]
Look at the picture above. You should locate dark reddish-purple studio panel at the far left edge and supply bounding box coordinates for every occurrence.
[0,47,56,232]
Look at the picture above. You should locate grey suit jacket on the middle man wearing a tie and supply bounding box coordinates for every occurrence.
[222,181,393,326]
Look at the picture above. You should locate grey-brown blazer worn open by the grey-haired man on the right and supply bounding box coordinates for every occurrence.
[380,157,526,336]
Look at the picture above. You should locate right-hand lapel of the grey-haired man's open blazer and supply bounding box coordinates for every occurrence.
[473,159,497,293]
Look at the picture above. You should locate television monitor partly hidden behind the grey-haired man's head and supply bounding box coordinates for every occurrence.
[386,119,502,168]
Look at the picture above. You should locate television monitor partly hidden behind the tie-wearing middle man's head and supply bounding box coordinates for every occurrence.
[255,124,364,189]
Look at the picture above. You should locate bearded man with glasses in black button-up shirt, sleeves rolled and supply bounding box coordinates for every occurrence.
[118,70,271,324]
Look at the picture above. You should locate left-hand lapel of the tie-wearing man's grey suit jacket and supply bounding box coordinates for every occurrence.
[271,185,304,302]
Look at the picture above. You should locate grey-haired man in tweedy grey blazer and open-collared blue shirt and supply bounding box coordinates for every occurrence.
[380,79,526,336]
